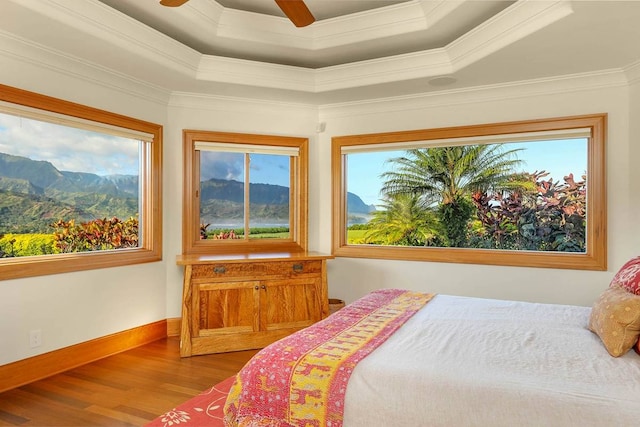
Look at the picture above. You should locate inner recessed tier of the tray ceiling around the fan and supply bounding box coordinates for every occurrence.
[100,0,513,68]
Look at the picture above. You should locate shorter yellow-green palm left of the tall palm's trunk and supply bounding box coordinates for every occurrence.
[364,194,442,246]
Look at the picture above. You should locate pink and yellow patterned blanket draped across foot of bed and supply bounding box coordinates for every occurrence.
[224,289,433,427]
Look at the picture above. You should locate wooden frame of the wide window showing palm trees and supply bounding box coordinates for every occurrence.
[331,114,607,270]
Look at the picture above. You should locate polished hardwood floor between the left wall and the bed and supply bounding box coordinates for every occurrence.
[0,337,257,427]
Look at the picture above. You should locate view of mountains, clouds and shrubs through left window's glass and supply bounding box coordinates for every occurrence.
[0,113,141,258]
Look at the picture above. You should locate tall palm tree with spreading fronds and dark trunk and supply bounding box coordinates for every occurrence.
[381,144,531,247]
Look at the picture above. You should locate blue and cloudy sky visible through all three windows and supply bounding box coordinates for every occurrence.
[0,113,587,205]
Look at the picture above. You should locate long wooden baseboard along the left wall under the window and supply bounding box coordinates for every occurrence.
[0,319,167,392]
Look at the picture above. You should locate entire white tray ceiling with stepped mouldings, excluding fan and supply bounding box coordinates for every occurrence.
[0,0,640,104]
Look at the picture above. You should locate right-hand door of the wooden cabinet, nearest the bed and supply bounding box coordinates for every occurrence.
[260,276,322,332]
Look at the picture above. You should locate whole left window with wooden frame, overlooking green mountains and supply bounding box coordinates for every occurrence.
[0,85,162,279]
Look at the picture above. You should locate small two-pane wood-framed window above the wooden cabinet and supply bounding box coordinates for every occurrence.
[183,130,308,254]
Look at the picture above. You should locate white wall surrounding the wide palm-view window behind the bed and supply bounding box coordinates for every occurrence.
[318,74,640,306]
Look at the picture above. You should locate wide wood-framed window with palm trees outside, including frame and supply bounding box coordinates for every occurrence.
[332,114,606,270]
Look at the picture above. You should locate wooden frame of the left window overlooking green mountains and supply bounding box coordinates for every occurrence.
[0,84,162,280]
